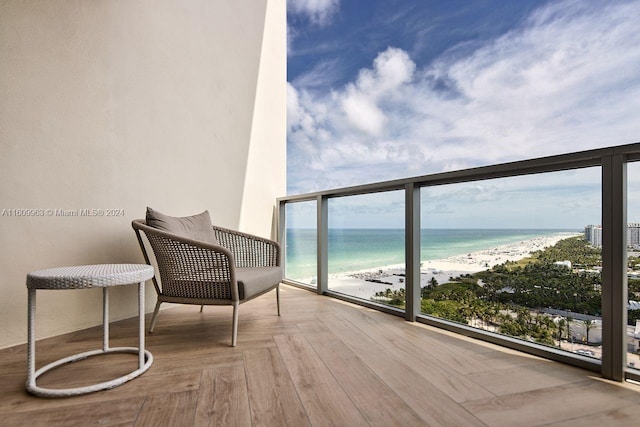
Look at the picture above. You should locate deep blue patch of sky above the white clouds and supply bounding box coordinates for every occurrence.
[287,0,545,91]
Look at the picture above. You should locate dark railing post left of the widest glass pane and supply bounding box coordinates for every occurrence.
[404,183,420,322]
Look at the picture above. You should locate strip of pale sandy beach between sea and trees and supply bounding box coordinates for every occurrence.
[329,234,578,299]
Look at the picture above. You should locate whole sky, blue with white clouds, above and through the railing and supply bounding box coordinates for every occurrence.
[287,0,640,228]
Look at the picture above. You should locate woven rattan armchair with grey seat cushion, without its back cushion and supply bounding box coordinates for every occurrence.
[132,220,283,347]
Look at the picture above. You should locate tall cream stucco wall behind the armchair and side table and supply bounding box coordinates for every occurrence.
[0,0,286,348]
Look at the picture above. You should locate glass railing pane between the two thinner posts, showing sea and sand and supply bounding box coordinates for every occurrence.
[328,191,405,308]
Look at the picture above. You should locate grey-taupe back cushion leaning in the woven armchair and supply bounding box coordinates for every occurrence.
[146,207,219,245]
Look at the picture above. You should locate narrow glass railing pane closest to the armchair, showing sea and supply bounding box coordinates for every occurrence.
[285,202,317,285]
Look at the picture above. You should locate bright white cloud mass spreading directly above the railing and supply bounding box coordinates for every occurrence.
[288,0,640,193]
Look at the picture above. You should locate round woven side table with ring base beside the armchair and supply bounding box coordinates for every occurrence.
[27,264,153,397]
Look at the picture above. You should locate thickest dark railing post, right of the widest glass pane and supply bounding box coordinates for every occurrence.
[602,154,627,381]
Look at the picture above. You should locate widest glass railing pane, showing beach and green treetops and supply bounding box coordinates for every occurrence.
[421,168,602,358]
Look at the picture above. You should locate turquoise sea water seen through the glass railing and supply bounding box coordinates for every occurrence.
[286,228,577,279]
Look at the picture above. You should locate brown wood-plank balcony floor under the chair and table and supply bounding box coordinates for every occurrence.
[0,285,640,427]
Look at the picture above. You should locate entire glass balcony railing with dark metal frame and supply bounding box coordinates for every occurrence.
[278,144,640,380]
